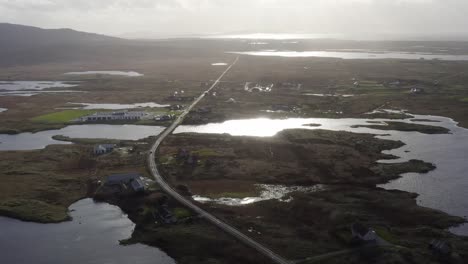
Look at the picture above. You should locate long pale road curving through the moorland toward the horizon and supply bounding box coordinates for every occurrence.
[148,57,290,264]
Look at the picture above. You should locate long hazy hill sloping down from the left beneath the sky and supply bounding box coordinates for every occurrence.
[0,23,242,67]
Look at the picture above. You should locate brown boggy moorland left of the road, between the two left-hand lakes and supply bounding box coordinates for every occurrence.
[0,137,276,264]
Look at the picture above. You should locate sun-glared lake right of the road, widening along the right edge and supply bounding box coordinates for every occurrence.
[174,115,468,235]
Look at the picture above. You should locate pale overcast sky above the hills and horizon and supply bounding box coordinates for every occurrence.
[0,0,468,38]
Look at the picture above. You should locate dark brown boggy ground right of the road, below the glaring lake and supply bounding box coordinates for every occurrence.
[147,130,468,263]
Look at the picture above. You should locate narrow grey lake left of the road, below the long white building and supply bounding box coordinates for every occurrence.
[0,125,164,150]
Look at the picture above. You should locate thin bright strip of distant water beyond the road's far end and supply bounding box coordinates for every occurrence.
[229,50,468,61]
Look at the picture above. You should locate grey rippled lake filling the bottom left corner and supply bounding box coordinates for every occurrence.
[0,199,175,264]
